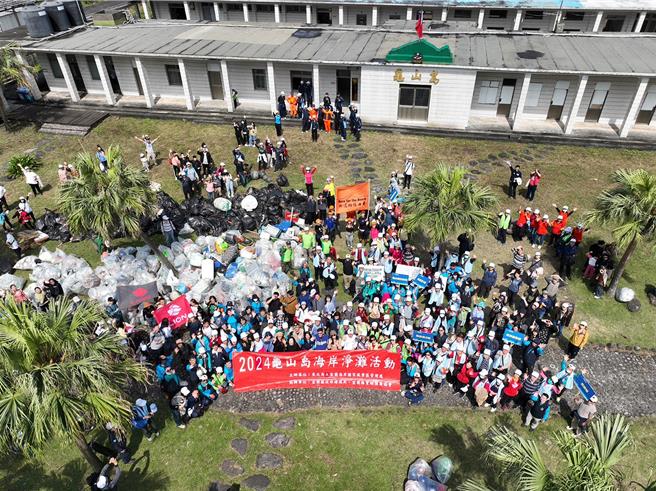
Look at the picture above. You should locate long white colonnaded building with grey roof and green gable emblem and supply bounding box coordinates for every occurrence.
[3,0,656,140]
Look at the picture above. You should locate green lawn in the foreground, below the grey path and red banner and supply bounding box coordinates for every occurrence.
[0,407,656,491]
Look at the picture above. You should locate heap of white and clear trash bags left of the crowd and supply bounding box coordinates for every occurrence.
[0,226,306,307]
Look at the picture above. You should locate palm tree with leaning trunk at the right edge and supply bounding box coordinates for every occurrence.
[585,169,656,295]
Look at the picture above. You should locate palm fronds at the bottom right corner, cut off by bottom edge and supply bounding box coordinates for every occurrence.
[458,415,632,491]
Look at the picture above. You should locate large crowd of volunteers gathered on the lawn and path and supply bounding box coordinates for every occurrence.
[0,103,613,489]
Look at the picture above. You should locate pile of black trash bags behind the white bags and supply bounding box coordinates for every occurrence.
[141,184,307,240]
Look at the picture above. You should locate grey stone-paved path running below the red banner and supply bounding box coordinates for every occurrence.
[212,345,656,416]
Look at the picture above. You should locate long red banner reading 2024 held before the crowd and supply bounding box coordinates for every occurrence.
[232,350,401,392]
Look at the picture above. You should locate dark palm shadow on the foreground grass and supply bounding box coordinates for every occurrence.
[431,413,512,491]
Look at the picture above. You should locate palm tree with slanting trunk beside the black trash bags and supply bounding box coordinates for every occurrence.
[60,146,177,273]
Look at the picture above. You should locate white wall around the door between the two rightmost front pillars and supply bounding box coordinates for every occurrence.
[576,77,638,125]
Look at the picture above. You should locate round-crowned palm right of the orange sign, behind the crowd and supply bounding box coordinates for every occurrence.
[403,163,497,244]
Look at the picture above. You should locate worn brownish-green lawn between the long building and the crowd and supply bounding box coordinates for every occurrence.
[0,117,656,348]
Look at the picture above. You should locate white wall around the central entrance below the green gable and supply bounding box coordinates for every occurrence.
[359,66,476,128]
